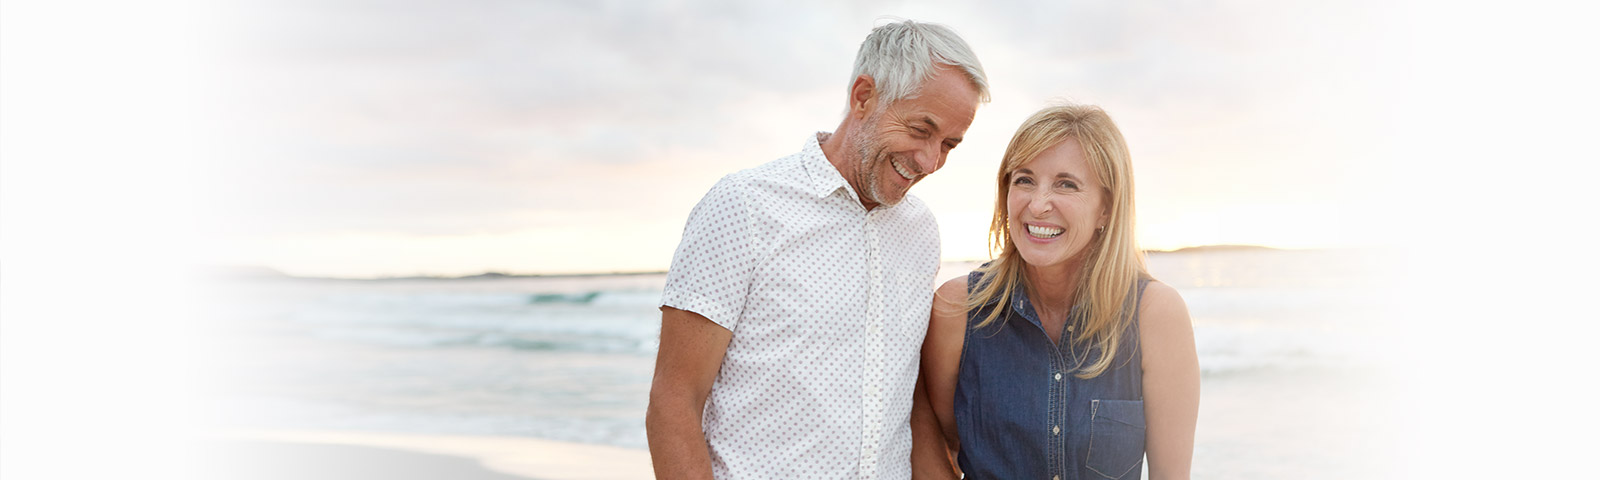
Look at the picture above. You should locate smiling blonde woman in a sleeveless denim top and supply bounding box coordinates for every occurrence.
[912,106,1200,480]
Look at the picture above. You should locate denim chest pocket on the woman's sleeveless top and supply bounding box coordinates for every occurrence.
[1085,400,1144,478]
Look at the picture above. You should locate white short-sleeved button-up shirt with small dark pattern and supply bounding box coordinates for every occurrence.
[661,133,939,480]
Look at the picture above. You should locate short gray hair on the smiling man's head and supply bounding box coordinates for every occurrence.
[850,19,989,106]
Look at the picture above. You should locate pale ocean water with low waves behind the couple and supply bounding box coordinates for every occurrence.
[197,250,1406,478]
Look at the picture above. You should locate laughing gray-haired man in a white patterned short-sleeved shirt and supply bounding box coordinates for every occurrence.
[645,21,989,478]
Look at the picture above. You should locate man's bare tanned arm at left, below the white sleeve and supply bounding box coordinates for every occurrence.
[645,307,733,480]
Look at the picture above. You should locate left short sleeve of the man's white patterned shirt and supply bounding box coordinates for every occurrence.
[661,178,758,330]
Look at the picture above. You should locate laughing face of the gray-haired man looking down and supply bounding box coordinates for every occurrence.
[850,66,978,208]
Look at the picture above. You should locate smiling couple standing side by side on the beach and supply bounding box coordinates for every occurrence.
[646,21,1200,480]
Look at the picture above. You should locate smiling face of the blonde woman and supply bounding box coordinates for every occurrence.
[1006,138,1109,267]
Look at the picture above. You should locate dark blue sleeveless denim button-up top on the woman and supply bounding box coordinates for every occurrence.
[955,272,1149,480]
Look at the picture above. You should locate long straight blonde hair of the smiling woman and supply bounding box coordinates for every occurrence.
[966,104,1150,379]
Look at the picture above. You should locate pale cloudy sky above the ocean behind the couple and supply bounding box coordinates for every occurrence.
[210,0,1427,273]
